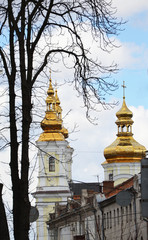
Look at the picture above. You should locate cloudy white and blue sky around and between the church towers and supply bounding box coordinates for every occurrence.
[0,0,148,214]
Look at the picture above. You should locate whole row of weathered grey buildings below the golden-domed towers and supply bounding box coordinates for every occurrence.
[48,175,148,240]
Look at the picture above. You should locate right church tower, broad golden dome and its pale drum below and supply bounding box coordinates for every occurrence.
[102,84,146,186]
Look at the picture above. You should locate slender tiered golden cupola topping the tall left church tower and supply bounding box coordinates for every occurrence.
[38,78,68,141]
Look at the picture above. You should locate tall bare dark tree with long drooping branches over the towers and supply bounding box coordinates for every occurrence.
[0,0,121,240]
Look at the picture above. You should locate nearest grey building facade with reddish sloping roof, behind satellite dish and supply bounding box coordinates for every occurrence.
[99,174,148,240]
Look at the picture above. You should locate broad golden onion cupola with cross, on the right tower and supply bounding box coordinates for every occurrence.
[104,86,146,164]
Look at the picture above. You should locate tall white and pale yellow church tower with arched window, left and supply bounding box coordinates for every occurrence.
[34,78,73,240]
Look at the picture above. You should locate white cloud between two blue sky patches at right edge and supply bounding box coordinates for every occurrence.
[91,39,148,69]
